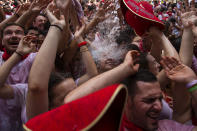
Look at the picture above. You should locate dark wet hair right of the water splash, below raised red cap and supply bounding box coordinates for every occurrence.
[115,25,136,45]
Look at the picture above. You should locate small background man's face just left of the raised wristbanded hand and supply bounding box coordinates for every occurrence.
[33,15,47,31]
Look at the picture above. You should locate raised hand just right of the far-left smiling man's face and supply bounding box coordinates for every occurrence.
[16,35,37,55]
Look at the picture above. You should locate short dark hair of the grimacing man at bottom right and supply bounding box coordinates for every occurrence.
[123,70,157,99]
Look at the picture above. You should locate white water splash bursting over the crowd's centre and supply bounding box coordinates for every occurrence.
[90,16,126,71]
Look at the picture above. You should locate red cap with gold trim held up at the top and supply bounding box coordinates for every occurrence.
[121,0,165,36]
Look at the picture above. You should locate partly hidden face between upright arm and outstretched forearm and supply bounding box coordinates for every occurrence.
[50,78,76,108]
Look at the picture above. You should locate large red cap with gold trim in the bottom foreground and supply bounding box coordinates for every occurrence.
[24,84,127,131]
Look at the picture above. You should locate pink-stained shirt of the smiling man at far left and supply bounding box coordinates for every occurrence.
[0,51,36,84]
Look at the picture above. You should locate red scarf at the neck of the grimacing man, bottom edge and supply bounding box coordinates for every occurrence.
[120,115,143,131]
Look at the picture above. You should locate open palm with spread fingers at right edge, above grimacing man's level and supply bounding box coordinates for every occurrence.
[161,57,197,83]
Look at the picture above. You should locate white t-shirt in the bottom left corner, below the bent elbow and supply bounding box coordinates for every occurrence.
[0,84,28,131]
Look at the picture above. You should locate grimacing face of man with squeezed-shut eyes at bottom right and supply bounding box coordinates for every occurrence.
[130,81,162,131]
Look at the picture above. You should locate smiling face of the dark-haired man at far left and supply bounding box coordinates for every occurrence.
[2,25,24,53]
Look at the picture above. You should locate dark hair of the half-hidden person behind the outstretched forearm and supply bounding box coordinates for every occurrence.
[48,72,72,103]
